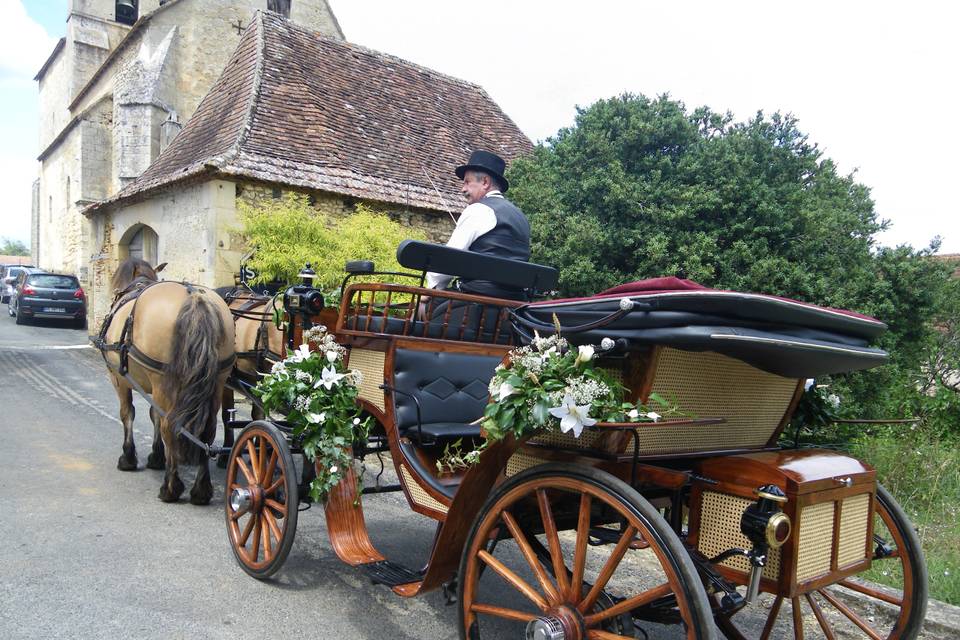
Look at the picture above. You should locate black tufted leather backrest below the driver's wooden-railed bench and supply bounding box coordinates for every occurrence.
[393,349,502,434]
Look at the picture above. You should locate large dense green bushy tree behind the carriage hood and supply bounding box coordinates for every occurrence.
[509,94,947,424]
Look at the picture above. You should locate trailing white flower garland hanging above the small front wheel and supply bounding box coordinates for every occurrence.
[253,325,370,501]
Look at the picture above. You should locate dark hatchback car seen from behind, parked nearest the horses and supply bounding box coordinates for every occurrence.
[7,269,87,328]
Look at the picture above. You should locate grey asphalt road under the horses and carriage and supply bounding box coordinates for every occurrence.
[0,307,948,640]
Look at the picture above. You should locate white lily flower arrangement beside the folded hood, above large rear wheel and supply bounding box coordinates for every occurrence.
[437,333,682,472]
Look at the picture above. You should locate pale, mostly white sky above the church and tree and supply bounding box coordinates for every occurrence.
[0,0,960,253]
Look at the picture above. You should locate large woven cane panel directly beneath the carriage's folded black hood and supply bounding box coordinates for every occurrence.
[627,348,797,454]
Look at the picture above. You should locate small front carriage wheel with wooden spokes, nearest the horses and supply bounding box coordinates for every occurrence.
[224,421,298,580]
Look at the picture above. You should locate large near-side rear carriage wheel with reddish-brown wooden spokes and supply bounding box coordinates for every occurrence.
[459,464,714,640]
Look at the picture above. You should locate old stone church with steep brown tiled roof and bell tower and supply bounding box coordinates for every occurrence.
[34,0,532,327]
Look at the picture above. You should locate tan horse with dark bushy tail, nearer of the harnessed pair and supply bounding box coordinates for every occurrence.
[96,259,234,504]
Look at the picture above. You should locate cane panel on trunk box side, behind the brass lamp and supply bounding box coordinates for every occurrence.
[697,491,780,580]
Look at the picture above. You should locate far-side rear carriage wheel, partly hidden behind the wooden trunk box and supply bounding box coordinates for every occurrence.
[717,485,927,640]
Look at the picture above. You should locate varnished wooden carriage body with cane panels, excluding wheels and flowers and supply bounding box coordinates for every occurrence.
[221,243,923,638]
